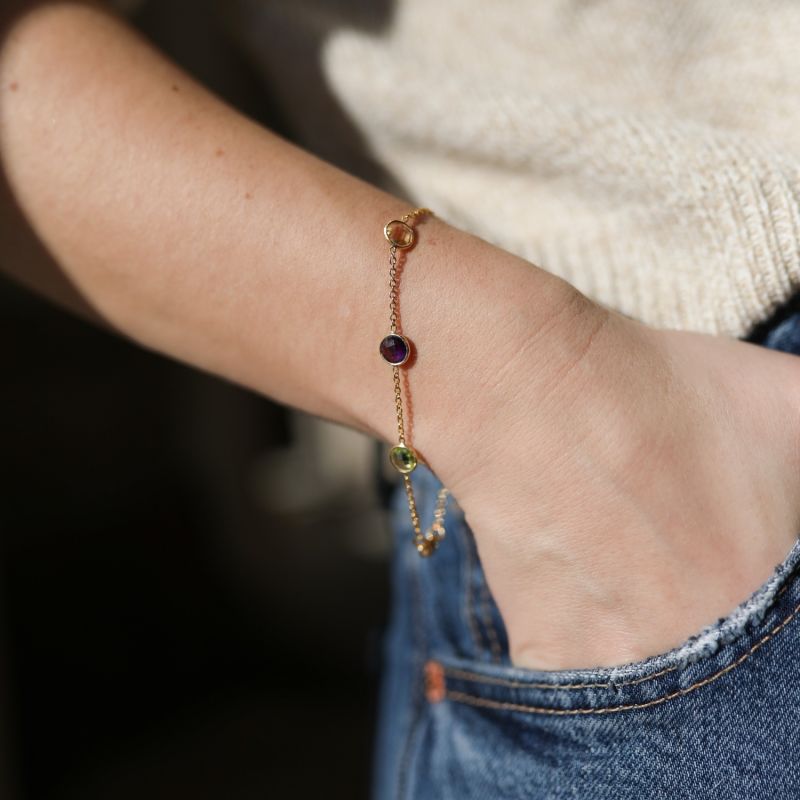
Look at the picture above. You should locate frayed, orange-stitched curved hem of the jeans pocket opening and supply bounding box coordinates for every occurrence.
[426,528,800,716]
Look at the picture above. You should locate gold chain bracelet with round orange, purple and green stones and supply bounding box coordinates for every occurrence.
[379,208,448,557]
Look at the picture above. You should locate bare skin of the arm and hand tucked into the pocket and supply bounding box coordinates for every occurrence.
[0,2,800,669]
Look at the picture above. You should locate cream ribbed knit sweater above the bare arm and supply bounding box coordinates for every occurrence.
[145,0,800,336]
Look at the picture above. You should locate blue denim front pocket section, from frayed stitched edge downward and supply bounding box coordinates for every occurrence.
[405,520,800,800]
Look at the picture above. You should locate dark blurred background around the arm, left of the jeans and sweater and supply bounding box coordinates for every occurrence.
[0,3,396,800]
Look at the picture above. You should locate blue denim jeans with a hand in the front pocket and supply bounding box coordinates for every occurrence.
[373,312,800,800]
